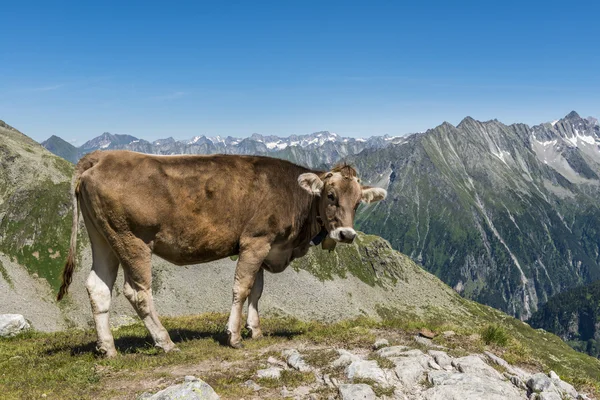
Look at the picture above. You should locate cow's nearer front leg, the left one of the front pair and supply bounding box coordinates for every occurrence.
[227,238,271,348]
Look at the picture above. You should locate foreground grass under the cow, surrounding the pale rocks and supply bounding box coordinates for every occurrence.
[0,314,600,399]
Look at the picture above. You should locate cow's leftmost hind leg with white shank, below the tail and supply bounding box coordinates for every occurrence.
[85,226,119,357]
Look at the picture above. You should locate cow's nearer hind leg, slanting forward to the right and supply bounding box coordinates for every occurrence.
[121,239,176,352]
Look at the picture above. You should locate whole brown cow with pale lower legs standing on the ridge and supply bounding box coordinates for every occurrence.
[57,151,386,357]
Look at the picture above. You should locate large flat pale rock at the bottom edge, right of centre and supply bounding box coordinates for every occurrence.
[421,371,525,400]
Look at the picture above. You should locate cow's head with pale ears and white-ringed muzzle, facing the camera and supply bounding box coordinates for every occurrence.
[298,165,387,243]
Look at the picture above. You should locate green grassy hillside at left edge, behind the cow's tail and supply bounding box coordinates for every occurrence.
[0,121,73,288]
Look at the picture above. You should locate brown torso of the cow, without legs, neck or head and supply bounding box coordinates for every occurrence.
[78,151,310,264]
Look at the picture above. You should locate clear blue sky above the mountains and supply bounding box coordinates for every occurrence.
[0,0,600,144]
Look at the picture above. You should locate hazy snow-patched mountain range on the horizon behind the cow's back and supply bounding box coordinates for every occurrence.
[42,131,403,168]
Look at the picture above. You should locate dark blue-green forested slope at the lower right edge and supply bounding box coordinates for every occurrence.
[528,281,600,357]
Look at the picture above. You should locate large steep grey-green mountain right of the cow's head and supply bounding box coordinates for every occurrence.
[348,112,600,319]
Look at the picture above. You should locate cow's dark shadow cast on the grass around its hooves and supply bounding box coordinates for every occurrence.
[45,328,303,356]
